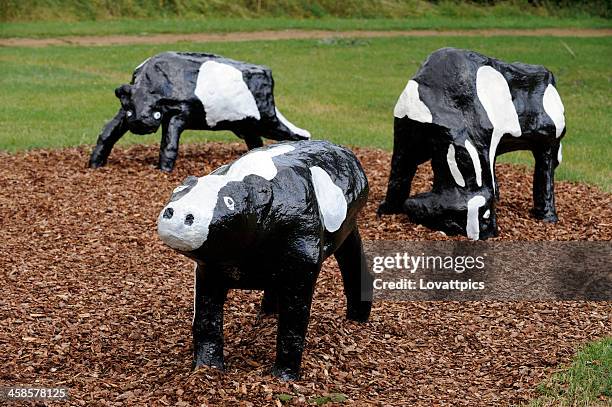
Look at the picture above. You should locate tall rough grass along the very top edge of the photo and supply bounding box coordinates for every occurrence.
[0,0,612,21]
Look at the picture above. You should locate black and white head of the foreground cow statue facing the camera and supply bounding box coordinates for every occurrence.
[157,173,272,259]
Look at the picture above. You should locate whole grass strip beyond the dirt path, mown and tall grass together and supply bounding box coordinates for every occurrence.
[0,0,612,37]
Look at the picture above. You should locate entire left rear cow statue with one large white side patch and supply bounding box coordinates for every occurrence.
[89,52,310,171]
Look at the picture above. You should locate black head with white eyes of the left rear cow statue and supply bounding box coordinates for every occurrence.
[115,84,164,134]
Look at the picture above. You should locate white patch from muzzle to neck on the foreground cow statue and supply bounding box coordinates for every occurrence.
[157,144,295,251]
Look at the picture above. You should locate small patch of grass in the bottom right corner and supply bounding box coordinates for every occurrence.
[529,337,612,407]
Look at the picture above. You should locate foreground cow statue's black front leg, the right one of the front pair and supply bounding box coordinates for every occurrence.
[272,262,321,380]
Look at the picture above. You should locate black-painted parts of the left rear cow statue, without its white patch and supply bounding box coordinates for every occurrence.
[89,52,305,171]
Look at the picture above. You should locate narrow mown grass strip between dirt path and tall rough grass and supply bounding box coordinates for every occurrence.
[0,14,612,38]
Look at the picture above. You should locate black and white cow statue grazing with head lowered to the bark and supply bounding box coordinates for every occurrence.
[378,48,565,240]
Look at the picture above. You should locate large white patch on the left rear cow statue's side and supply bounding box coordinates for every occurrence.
[194,61,261,127]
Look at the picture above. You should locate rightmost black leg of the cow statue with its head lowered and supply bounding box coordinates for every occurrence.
[531,142,559,222]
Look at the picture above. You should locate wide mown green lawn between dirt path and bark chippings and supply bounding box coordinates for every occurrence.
[0,37,612,191]
